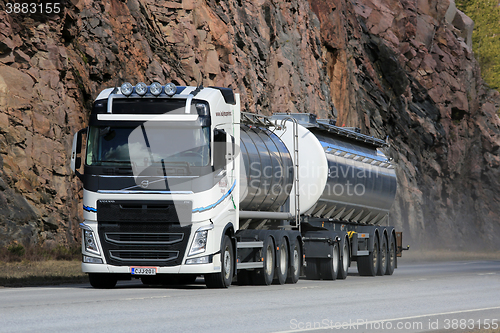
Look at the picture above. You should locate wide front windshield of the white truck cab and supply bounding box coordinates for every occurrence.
[86,122,210,169]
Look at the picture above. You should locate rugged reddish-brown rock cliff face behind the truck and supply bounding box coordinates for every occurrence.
[0,0,500,248]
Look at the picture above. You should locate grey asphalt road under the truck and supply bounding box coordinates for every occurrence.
[0,261,500,333]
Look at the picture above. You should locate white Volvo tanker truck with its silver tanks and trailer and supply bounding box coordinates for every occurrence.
[71,82,403,288]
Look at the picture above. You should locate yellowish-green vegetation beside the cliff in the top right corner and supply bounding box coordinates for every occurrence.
[456,0,500,90]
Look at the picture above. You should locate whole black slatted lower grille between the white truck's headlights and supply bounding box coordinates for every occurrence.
[98,222,191,266]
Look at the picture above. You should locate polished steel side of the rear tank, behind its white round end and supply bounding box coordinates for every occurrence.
[307,129,397,224]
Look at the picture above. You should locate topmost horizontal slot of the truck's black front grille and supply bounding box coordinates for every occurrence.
[106,232,184,245]
